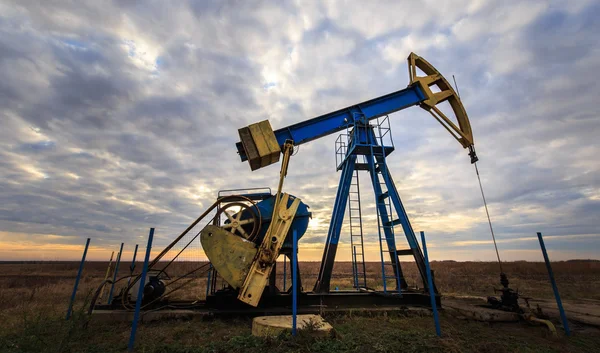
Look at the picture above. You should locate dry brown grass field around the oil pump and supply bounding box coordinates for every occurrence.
[0,261,600,352]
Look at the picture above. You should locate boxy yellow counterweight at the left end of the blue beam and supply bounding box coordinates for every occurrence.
[238,120,281,170]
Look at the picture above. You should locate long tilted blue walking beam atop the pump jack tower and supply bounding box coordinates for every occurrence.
[238,85,425,161]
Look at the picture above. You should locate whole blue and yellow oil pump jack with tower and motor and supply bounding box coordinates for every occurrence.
[109,53,477,309]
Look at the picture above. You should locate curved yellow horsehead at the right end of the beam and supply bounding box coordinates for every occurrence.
[408,53,474,148]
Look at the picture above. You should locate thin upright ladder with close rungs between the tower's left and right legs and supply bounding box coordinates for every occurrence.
[348,170,367,289]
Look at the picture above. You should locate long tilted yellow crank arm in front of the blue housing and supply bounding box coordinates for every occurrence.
[238,193,300,306]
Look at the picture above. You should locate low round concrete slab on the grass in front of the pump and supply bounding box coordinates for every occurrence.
[252,314,333,337]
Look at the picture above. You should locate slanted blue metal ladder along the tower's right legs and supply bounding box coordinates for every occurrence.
[371,146,402,295]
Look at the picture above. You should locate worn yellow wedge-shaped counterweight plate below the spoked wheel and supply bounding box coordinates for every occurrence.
[200,225,257,288]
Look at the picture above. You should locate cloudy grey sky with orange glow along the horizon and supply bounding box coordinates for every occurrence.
[0,0,600,261]
